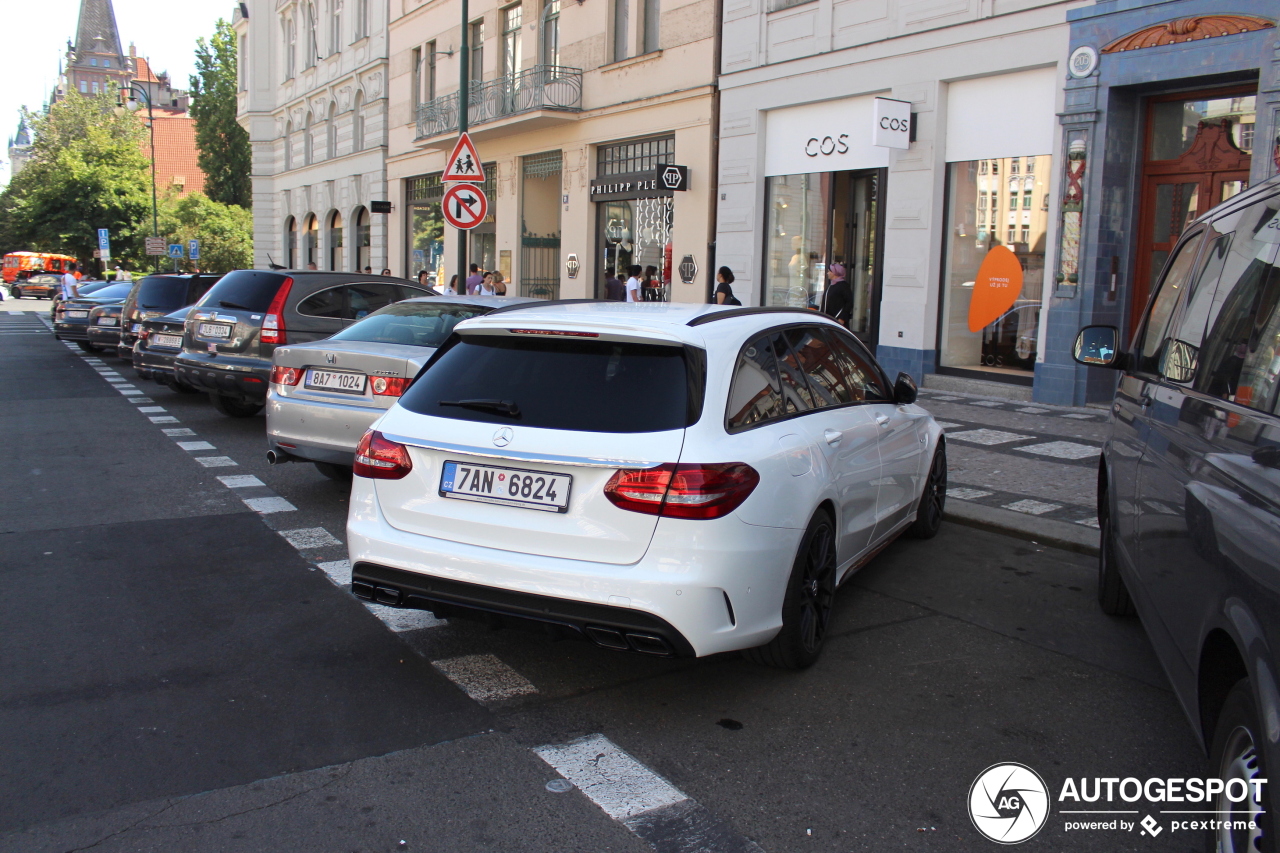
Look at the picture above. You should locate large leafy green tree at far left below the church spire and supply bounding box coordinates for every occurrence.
[0,92,151,266]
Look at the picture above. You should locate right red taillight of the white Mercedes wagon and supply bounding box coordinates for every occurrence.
[604,462,760,519]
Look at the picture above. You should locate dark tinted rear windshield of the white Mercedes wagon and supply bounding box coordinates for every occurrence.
[401,336,703,433]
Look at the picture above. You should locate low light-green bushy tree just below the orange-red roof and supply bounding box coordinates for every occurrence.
[160,192,253,273]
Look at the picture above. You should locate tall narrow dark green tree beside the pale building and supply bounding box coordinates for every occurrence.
[191,18,252,207]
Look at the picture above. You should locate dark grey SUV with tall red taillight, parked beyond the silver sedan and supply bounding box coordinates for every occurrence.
[174,269,428,418]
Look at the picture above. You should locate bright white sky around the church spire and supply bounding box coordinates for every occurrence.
[0,0,237,186]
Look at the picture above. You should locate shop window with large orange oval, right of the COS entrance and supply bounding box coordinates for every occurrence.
[938,155,1048,380]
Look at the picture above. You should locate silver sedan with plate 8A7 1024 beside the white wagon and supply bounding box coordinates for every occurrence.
[266,296,535,479]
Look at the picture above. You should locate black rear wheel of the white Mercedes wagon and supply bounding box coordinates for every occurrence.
[744,511,836,670]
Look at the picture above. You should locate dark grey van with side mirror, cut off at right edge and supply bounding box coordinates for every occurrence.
[1074,169,1280,850]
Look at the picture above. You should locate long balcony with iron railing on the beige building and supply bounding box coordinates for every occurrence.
[417,65,582,141]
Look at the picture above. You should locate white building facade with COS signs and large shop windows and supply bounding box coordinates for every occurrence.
[716,0,1084,400]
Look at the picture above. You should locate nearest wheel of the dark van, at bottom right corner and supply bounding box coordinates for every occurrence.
[1204,679,1274,853]
